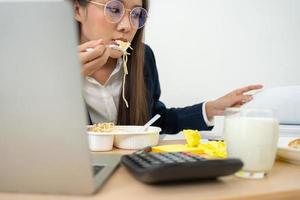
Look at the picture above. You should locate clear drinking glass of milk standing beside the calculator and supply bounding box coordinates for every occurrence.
[224,108,279,179]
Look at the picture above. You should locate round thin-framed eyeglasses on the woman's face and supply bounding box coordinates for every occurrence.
[88,0,148,29]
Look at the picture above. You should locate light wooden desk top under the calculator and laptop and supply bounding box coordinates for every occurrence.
[0,141,300,200]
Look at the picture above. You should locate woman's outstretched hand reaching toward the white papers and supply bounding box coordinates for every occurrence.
[205,85,263,119]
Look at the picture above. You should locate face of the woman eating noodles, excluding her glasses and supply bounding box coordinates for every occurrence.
[75,0,142,58]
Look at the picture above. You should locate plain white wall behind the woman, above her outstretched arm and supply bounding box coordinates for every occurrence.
[145,0,300,138]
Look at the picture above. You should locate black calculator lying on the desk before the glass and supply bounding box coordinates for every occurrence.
[121,151,243,184]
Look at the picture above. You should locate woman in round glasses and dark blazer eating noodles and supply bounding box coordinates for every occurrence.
[74,0,262,134]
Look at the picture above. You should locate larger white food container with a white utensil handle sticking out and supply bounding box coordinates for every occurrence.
[114,126,161,150]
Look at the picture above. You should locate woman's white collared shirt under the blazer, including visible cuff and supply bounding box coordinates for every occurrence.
[83,59,214,126]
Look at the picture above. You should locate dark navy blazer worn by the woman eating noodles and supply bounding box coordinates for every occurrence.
[88,45,212,134]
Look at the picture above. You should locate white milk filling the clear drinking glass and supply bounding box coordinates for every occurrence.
[224,116,279,172]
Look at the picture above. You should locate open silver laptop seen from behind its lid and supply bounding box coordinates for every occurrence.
[0,0,120,194]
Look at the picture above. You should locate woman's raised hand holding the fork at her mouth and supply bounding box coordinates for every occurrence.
[78,40,110,76]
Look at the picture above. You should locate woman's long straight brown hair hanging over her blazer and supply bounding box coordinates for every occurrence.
[74,0,149,125]
